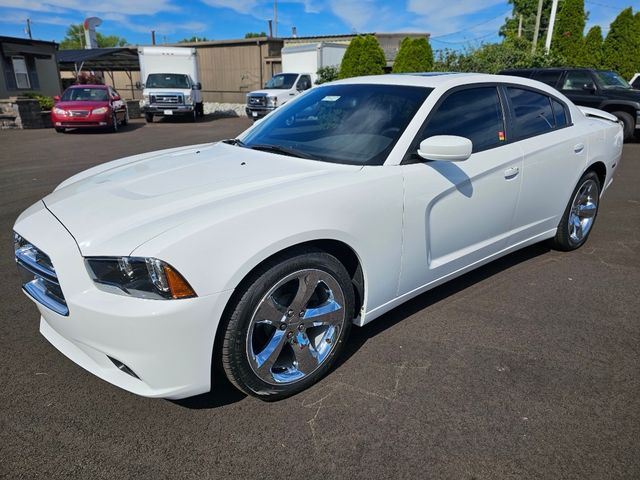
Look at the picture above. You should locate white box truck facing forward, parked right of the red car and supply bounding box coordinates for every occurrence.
[138,47,204,122]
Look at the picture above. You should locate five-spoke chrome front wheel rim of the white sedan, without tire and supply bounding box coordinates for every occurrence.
[246,269,346,385]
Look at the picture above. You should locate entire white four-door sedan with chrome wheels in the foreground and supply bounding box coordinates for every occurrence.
[15,74,622,400]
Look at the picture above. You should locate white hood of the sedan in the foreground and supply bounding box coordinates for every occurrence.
[43,143,361,256]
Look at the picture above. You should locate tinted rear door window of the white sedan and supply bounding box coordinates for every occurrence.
[507,87,555,138]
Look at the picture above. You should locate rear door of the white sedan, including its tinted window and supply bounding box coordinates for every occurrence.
[504,86,588,244]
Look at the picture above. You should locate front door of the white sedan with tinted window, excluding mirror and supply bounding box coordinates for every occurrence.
[399,85,522,295]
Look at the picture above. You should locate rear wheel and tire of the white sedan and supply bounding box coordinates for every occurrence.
[553,171,601,252]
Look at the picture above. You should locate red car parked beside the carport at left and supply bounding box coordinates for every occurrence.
[51,85,129,133]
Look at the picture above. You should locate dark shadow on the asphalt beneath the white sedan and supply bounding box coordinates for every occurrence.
[174,243,550,410]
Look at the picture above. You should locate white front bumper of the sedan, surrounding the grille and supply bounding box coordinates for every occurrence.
[15,202,231,399]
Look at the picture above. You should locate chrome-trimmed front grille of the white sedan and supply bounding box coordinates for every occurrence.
[14,233,69,316]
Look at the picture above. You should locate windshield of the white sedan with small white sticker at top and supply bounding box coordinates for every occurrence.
[239,84,432,165]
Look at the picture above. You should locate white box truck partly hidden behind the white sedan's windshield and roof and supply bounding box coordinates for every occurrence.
[245,42,347,120]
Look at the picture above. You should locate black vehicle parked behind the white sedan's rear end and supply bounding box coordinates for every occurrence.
[500,68,640,140]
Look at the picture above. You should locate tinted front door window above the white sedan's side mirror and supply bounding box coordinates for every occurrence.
[420,87,505,152]
